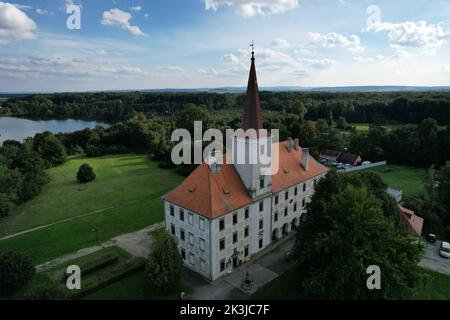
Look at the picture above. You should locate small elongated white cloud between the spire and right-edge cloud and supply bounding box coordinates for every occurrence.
[309,32,364,53]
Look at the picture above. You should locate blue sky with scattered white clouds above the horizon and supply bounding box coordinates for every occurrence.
[0,0,450,92]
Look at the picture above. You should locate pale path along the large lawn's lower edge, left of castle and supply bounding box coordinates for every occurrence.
[36,222,164,272]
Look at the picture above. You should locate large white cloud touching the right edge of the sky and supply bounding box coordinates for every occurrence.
[364,21,450,53]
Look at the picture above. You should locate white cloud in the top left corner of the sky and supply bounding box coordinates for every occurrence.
[0,2,36,44]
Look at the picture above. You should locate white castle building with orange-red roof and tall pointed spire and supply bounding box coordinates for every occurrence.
[162,48,328,280]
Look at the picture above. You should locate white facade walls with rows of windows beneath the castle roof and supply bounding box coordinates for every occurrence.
[164,173,325,280]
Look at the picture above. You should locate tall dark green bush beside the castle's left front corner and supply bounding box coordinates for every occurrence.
[147,232,183,293]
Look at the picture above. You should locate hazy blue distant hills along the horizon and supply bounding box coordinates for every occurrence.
[0,86,450,97]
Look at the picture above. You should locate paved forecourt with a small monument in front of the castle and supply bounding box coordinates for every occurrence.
[182,233,295,300]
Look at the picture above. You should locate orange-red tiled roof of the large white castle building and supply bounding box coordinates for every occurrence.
[163,142,328,218]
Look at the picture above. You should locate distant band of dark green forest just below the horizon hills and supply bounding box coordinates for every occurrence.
[0,92,450,124]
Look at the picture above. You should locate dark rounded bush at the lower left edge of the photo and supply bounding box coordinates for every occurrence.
[0,251,35,295]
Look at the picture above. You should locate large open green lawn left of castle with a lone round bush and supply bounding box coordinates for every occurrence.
[0,154,182,264]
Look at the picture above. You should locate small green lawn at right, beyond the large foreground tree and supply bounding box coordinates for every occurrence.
[352,165,428,197]
